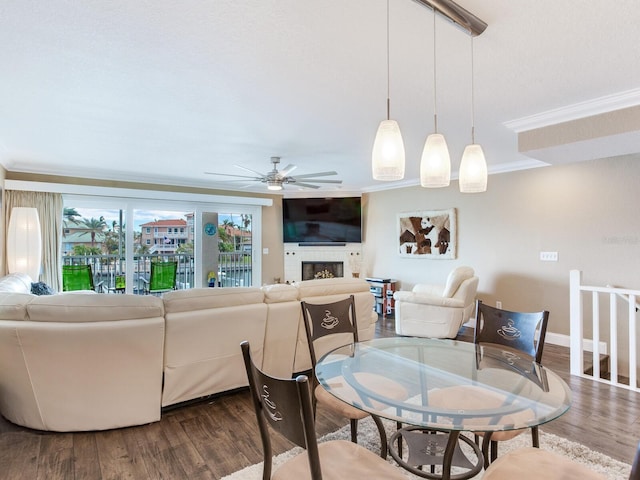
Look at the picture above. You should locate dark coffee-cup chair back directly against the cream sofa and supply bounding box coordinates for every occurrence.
[300,295,358,368]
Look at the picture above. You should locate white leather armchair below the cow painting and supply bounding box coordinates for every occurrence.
[393,267,479,338]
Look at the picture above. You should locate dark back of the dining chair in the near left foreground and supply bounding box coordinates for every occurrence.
[240,341,322,480]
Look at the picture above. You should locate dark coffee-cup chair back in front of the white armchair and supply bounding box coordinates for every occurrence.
[474,300,549,363]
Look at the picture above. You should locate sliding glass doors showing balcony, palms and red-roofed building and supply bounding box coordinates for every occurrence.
[62,195,261,293]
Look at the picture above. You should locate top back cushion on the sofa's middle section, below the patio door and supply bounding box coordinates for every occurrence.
[162,287,264,313]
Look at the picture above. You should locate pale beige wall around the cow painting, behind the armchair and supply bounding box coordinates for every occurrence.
[361,156,640,334]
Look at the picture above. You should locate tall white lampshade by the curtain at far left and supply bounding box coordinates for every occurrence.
[7,207,42,282]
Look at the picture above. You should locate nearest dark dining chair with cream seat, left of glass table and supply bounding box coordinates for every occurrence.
[241,341,406,480]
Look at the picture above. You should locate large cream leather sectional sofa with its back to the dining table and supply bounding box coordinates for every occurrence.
[0,274,377,431]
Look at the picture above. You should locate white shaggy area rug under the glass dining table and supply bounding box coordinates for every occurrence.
[222,419,631,480]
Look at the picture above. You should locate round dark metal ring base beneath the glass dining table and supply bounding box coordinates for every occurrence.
[389,426,484,480]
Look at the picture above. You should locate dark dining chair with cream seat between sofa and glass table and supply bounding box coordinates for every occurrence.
[301,295,408,458]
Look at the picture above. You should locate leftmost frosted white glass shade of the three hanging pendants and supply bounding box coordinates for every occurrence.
[371,120,404,181]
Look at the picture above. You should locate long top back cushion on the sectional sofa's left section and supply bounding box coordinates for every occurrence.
[27,293,164,322]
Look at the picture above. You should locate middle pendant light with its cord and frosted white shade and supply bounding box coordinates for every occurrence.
[420,9,451,188]
